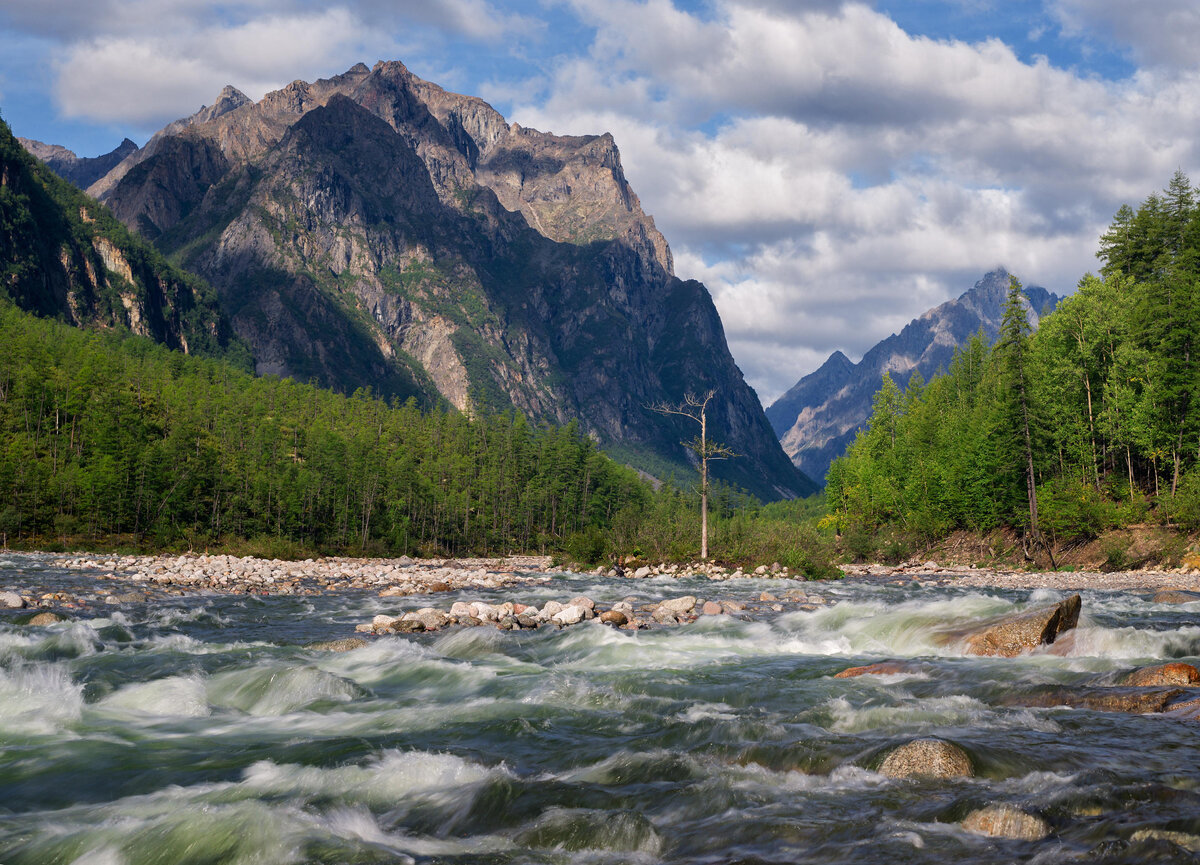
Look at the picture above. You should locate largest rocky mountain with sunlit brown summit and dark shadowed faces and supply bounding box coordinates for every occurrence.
[68,62,816,499]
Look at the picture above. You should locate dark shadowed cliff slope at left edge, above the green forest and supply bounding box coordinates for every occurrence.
[0,120,246,361]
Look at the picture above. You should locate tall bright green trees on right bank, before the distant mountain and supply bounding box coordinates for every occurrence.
[827,173,1200,547]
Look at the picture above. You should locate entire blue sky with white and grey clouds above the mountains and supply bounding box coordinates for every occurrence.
[0,0,1200,406]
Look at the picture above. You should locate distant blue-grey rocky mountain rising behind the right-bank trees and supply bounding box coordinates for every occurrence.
[767,268,1061,480]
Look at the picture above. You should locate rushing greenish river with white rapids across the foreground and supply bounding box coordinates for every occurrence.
[0,555,1200,865]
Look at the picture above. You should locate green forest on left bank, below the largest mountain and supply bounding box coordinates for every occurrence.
[0,300,657,553]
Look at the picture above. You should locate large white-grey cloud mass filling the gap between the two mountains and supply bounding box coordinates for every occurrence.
[515,0,1200,402]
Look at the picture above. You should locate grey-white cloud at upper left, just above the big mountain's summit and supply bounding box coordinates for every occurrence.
[7,0,540,130]
